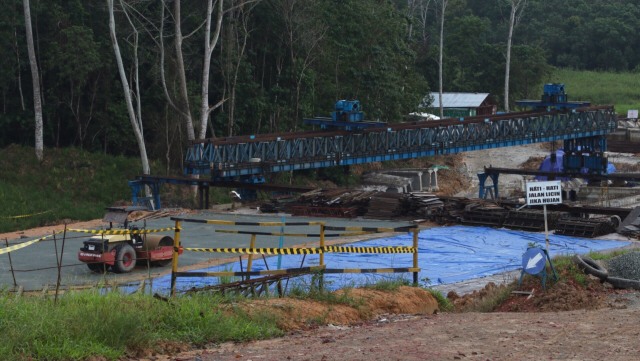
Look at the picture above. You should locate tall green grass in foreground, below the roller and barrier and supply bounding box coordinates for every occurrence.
[0,291,282,360]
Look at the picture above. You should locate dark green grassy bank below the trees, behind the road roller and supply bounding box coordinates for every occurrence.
[0,145,141,232]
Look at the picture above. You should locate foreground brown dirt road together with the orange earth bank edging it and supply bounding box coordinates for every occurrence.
[138,285,640,361]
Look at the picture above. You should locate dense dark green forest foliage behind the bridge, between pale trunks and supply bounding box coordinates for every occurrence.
[0,0,640,167]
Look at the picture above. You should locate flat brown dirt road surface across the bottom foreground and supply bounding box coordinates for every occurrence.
[196,309,640,361]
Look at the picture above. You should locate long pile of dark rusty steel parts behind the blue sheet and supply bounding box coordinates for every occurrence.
[260,189,624,238]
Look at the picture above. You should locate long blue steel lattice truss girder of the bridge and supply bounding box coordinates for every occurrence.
[185,107,616,177]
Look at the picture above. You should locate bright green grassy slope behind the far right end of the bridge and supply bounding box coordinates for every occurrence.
[546,69,640,112]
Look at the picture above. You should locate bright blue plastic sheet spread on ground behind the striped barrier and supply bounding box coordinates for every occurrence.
[136,226,630,293]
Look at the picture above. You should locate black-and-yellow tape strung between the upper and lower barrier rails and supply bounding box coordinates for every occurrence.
[184,246,415,255]
